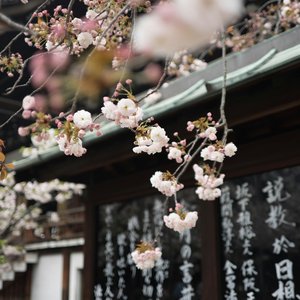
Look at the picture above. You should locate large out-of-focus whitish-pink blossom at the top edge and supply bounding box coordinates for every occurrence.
[134,0,242,56]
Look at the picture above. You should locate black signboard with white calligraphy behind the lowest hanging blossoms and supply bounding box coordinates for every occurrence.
[94,189,201,300]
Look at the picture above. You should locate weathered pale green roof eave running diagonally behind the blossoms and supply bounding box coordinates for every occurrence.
[8,26,300,171]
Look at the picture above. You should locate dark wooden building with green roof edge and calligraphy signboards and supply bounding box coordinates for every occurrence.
[4,28,300,300]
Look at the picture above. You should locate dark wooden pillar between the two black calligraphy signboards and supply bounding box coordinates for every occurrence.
[200,201,222,300]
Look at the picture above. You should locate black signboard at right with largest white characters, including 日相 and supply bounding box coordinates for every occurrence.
[221,167,300,300]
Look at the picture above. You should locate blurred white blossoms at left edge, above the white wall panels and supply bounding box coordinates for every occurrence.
[0,172,85,276]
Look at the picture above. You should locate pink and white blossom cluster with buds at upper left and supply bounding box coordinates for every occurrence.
[25,1,131,55]
